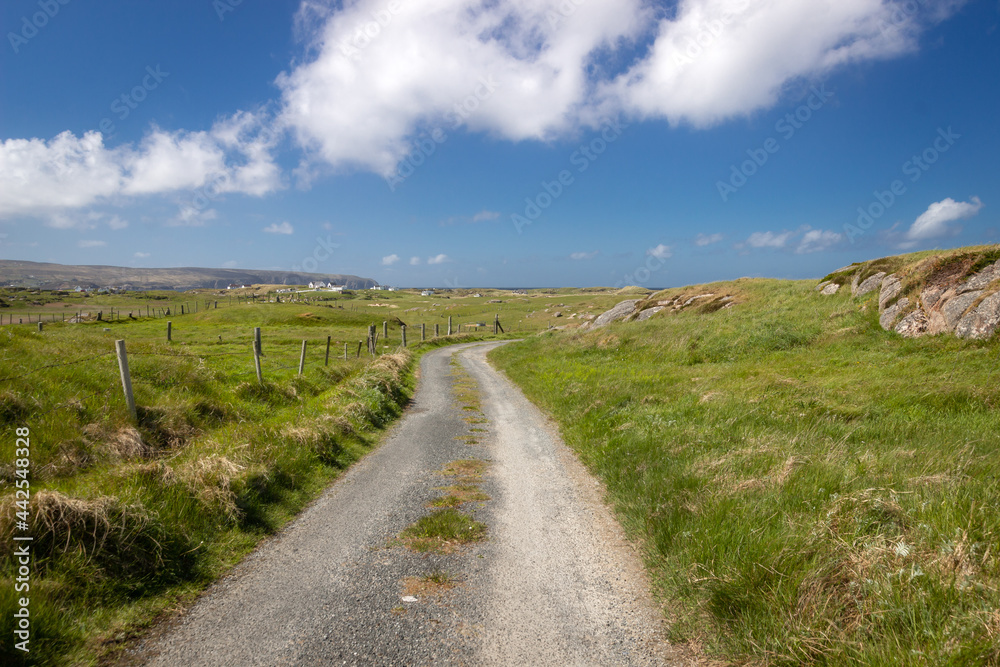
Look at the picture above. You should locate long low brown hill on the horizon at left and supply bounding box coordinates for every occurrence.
[0,260,378,290]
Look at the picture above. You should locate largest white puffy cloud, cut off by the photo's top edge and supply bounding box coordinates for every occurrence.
[277,0,961,175]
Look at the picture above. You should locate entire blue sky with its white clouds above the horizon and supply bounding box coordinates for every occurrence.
[0,0,1000,287]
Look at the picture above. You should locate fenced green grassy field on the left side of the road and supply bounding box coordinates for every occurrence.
[0,290,617,665]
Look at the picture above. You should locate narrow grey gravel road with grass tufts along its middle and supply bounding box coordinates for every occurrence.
[139,343,682,666]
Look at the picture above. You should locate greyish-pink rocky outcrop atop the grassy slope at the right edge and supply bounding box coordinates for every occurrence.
[832,255,1000,340]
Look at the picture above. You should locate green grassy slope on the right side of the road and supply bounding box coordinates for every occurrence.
[491,271,1000,665]
